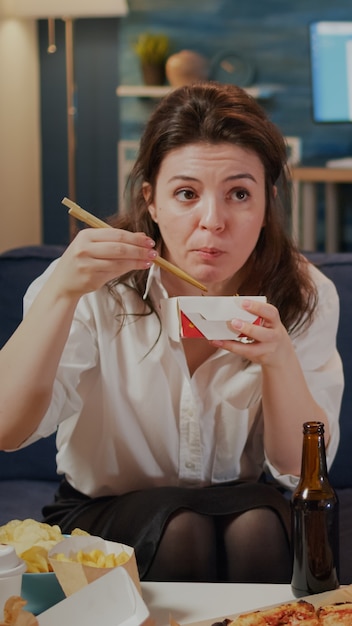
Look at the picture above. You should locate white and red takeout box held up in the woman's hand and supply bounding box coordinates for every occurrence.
[161,296,266,343]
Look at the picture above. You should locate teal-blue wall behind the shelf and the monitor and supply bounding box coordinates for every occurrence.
[118,0,352,158]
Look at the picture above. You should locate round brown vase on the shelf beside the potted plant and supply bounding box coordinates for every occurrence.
[165,50,209,87]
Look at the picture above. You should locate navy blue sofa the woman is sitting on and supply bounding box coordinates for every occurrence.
[0,245,352,583]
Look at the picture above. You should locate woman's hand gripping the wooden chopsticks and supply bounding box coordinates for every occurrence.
[53,228,157,298]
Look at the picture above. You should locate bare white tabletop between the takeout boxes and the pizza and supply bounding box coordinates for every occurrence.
[141,582,294,626]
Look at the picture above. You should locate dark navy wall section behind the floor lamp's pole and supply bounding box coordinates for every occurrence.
[39,18,119,244]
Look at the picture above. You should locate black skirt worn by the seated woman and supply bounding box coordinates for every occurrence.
[43,480,290,579]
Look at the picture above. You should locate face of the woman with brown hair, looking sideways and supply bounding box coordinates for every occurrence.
[145,143,265,295]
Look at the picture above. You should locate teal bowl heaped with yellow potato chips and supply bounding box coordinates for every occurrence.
[0,519,73,615]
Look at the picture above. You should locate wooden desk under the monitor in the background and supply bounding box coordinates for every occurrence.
[291,166,352,252]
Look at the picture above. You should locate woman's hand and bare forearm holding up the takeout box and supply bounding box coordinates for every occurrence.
[212,300,330,476]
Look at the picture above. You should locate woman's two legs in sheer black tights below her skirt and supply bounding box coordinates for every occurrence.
[144,508,291,583]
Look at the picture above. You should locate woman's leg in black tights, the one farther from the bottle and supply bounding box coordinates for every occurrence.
[143,510,216,582]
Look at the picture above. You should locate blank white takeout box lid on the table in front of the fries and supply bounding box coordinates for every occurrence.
[37,566,150,626]
